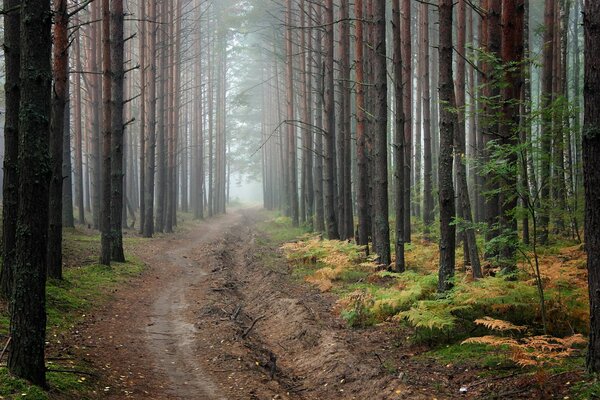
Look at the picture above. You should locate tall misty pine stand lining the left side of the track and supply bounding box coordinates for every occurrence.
[0,0,231,386]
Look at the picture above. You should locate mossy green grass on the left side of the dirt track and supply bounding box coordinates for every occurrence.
[0,229,145,400]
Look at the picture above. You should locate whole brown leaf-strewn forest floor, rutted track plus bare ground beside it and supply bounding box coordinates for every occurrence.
[0,209,596,400]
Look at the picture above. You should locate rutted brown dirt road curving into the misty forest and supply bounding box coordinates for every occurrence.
[75,210,474,399]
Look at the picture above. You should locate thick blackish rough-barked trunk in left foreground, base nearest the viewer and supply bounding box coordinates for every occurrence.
[8,0,52,386]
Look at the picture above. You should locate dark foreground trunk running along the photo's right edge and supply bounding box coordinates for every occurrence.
[582,0,600,372]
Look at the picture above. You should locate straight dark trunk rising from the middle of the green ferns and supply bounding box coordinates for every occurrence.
[438,0,456,292]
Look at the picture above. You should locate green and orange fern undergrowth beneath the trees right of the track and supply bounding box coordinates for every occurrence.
[270,216,598,390]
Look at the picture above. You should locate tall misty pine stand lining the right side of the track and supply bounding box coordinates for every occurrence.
[261,0,600,370]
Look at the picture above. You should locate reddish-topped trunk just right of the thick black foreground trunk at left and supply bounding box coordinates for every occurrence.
[47,0,70,279]
